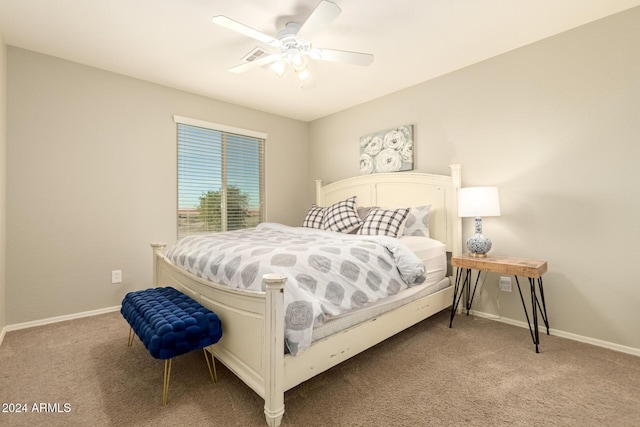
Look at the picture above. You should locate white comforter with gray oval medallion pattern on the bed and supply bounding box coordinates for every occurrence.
[166,223,425,355]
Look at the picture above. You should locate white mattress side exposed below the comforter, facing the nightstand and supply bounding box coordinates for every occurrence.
[312,236,451,342]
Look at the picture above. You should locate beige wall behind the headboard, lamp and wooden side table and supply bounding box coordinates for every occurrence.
[310,8,640,352]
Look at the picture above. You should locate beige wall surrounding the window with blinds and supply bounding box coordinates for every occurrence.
[3,47,312,324]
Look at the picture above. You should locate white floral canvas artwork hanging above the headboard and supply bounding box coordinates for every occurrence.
[360,125,413,175]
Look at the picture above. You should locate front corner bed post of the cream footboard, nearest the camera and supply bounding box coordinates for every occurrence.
[262,274,287,427]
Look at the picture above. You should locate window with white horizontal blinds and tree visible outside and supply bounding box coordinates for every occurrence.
[174,116,266,237]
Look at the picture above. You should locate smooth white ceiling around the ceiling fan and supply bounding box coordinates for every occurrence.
[0,0,640,121]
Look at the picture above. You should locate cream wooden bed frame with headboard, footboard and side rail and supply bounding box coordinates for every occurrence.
[151,165,462,427]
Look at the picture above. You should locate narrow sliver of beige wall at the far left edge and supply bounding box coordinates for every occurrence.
[0,34,7,334]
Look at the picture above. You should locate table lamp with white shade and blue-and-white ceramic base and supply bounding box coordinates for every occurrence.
[458,187,500,258]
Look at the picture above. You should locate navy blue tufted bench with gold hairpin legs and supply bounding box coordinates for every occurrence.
[120,287,222,405]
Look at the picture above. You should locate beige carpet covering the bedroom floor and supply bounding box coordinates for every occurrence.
[0,312,640,427]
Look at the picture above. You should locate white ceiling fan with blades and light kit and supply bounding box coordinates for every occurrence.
[213,0,373,87]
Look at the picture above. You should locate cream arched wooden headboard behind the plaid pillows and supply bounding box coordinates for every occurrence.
[316,165,462,255]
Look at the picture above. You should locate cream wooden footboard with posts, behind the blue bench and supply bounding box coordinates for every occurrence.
[151,243,286,426]
